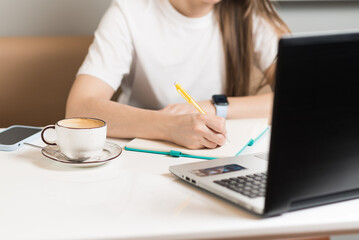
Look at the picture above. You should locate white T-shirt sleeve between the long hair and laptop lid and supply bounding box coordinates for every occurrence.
[253,15,278,72]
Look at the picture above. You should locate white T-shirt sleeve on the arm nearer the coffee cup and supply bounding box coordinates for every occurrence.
[77,0,133,91]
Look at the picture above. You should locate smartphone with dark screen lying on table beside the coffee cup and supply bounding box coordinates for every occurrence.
[0,125,42,151]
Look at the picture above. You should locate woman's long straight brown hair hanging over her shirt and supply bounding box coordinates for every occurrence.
[215,0,289,96]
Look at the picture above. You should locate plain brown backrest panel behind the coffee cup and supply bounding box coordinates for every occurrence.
[0,36,93,127]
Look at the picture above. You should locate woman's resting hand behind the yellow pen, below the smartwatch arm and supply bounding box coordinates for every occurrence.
[160,101,216,114]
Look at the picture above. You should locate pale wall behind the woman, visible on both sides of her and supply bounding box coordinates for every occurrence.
[0,0,359,36]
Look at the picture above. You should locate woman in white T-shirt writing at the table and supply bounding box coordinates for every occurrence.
[66,0,288,149]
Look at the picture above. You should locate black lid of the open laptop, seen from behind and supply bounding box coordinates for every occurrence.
[265,33,359,215]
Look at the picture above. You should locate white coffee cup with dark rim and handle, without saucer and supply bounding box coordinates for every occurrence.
[41,117,107,160]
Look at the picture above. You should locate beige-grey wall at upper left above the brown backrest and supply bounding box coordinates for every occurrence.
[0,0,111,36]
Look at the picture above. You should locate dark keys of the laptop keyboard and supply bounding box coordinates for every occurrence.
[214,173,267,198]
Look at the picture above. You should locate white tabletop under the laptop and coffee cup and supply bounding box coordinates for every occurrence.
[0,129,359,240]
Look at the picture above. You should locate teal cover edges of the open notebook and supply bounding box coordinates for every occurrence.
[125,127,269,160]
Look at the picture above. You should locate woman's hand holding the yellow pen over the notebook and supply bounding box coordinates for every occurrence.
[168,113,226,149]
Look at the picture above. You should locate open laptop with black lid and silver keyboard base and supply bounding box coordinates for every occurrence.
[169,32,359,217]
